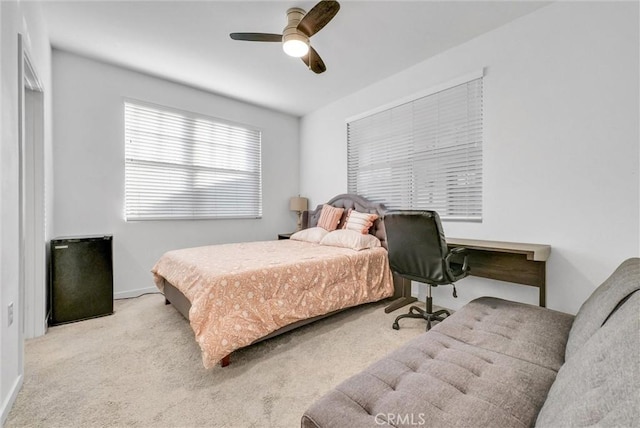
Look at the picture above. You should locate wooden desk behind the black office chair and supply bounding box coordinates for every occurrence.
[385,238,551,313]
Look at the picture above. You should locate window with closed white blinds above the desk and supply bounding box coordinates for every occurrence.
[347,73,482,221]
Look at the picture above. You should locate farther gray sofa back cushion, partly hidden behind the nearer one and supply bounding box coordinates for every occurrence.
[565,258,640,360]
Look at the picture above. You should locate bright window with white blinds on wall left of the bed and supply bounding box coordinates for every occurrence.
[124,101,262,220]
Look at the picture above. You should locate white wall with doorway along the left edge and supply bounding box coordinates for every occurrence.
[0,1,51,424]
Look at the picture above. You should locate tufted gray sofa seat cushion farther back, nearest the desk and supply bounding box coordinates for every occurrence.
[432,297,574,371]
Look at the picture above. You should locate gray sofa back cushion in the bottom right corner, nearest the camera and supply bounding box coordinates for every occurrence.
[536,292,640,427]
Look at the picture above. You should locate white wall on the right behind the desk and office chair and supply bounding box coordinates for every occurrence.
[300,2,640,313]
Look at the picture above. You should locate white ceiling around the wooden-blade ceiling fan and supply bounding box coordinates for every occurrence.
[44,0,549,116]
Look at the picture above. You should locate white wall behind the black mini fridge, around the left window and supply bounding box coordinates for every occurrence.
[53,50,299,297]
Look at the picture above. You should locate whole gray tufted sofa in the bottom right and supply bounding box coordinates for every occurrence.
[302,258,640,428]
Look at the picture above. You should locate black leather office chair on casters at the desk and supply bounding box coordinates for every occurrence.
[384,211,469,330]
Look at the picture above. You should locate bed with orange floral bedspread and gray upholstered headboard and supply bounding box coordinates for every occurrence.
[152,194,394,368]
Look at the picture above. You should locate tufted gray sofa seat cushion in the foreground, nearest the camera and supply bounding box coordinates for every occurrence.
[302,330,556,427]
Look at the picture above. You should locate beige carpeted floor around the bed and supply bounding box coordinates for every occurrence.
[5,294,425,428]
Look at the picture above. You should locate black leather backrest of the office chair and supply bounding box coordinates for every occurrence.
[384,210,451,285]
